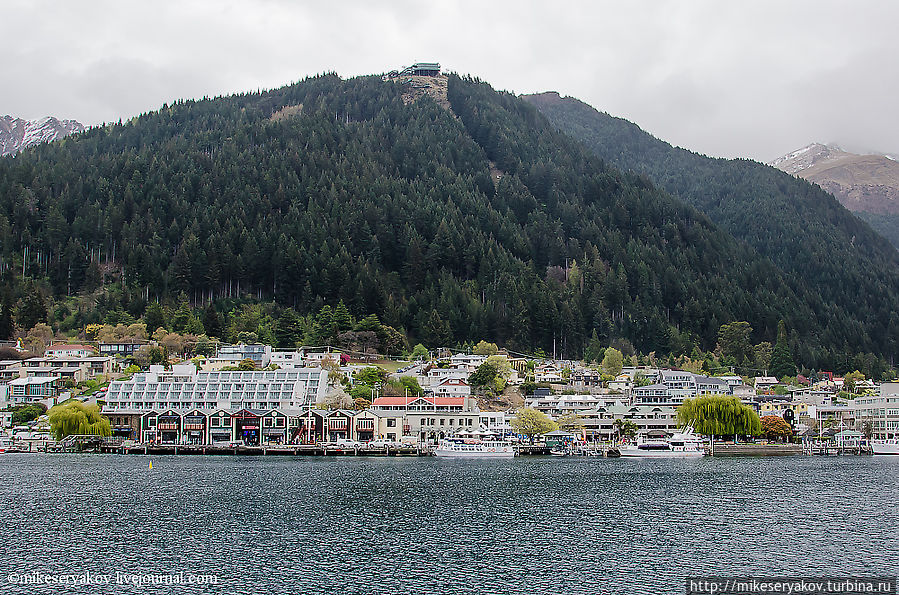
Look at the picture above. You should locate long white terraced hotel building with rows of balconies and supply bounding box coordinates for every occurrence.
[106,365,328,411]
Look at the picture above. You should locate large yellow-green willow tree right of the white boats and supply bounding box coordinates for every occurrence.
[677,395,762,437]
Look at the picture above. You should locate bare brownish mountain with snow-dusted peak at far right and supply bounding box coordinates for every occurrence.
[770,143,899,247]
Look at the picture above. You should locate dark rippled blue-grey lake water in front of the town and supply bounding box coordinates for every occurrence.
[0,454,899,595]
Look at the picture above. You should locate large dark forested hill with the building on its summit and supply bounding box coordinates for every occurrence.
[0,75,884,367]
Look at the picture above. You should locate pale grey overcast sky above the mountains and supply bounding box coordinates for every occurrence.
[0,0,899,161]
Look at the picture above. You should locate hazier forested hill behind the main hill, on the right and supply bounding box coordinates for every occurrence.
[524,92,899,366]
